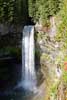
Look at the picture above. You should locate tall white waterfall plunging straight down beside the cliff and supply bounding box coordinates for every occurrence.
[22,25,37,90]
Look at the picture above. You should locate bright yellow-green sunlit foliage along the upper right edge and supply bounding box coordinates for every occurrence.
[56,0,67,46]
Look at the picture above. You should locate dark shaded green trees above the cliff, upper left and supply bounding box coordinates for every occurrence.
[0,0,28,23]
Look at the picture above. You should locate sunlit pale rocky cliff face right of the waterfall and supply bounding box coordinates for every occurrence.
[35,19,65,100]
